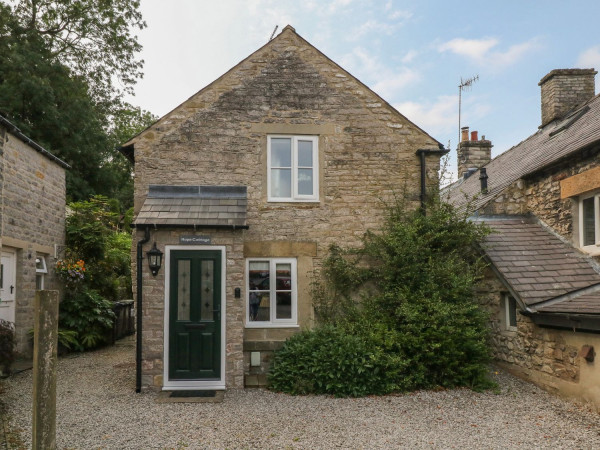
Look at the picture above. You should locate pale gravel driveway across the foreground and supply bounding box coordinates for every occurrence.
[0,339,600,449]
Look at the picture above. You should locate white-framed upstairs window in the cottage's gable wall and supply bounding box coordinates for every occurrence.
[267,136,319,202]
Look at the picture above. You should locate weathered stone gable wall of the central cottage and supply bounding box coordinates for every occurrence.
[134,27,439,388]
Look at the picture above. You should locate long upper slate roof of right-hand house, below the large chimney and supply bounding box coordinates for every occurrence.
[444,95,600,210]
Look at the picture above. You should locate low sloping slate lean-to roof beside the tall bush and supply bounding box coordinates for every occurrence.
[478,216,600,313]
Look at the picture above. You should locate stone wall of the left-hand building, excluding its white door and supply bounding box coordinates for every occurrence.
[2,133,66,354]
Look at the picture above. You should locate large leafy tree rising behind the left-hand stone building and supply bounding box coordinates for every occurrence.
[0,0,154,204]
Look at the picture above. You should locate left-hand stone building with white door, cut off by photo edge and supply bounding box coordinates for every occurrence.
[0,116,69,356]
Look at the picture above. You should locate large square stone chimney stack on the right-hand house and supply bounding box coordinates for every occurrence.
[538,69,598,128]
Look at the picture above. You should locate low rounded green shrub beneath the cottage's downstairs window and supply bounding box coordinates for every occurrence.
[269,326,398,397]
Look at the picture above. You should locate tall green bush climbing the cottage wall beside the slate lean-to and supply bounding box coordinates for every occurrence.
[271,200,490,394]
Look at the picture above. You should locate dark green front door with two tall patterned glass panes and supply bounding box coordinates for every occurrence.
[169,250,222,380]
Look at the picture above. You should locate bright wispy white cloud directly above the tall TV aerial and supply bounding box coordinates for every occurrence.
[438,38,539,69]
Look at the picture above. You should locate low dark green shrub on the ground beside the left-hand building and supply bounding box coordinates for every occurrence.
[59,288,115,350]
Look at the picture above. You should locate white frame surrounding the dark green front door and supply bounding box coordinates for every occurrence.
[162,245,227,391]
